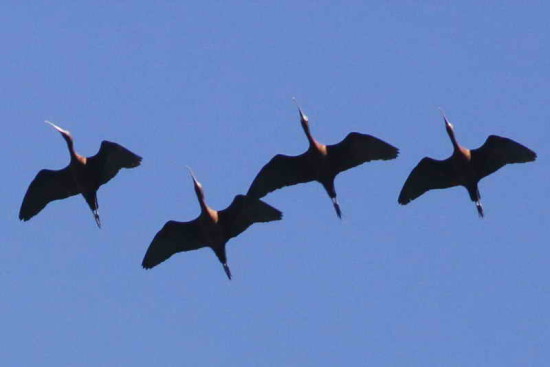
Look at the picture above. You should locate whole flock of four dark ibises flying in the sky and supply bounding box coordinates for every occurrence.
[19,100,537,279]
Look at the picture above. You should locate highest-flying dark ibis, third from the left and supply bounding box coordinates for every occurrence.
[247,100,399,218]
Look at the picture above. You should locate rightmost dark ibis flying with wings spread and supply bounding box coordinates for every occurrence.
[398,110,537,217]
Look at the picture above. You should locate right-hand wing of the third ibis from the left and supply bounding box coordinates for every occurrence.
[327,132,399,174]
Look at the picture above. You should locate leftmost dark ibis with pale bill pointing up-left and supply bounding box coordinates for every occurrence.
[19,121,141,228]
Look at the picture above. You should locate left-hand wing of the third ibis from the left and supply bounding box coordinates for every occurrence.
[247,153,315,199]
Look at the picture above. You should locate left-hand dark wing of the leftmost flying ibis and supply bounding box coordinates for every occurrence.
[19,166,78,221]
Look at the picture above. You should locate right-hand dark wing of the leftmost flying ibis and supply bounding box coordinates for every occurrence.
[87,140,141,185]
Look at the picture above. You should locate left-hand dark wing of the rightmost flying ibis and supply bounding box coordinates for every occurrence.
[397,157,458,205]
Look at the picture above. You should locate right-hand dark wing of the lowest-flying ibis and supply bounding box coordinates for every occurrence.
[218,195,283,239]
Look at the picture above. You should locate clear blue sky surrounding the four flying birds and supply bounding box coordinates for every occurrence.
[0,1,550,367]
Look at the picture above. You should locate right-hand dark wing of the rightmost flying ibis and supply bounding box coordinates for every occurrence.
[470,135,537,179]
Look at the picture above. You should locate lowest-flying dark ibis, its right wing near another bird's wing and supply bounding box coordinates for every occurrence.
[141,168,282,279]
